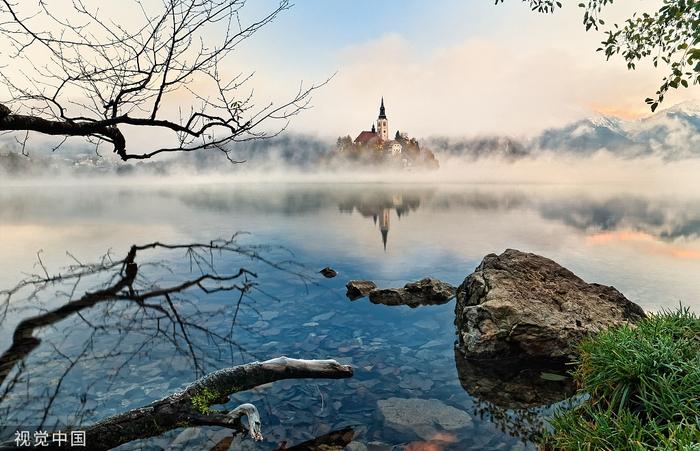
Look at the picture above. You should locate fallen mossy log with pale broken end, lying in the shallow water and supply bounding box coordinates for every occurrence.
[0,357,353,451]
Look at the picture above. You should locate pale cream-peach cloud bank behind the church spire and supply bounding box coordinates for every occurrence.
[280,5,692,136]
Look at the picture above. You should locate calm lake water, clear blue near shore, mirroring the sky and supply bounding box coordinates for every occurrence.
[0,182,700,450]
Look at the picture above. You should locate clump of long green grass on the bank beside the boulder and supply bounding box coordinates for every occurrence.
[544,307,700,451]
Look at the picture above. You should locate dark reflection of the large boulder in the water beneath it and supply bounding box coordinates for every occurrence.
[455,348,575,441]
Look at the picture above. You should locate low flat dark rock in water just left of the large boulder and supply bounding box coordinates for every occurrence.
[369,278,456,308]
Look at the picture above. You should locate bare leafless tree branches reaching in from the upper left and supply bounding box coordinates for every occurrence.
[0,0,323,161]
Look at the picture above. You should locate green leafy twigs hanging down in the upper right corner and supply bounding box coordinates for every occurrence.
[496,0,700,112]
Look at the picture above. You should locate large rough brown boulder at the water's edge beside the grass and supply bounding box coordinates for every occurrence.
[455,249,645,358]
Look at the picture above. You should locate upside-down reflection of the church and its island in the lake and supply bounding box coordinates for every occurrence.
[339,192,420,251]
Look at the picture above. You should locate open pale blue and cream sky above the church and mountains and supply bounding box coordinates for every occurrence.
[236,0,700,137]
